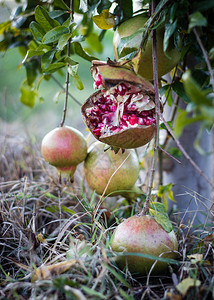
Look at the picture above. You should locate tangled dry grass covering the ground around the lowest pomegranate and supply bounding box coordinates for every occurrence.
[0,129,214,300]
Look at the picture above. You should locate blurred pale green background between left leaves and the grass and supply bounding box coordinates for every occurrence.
[0,0,114,142]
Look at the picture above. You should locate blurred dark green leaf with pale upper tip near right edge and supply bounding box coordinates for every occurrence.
[182,70,212,106]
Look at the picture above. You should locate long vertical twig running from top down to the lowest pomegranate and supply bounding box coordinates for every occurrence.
[140,0,160,216]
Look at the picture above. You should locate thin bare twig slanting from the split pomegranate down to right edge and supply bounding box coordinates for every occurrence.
[157,111,214,188]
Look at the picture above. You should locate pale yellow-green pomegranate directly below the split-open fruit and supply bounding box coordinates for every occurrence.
[84,142,140,196]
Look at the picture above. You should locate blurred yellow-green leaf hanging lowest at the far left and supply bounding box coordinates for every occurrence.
[19,79,37,108]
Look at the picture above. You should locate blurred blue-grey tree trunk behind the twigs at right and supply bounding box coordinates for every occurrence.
[163,106,214,225]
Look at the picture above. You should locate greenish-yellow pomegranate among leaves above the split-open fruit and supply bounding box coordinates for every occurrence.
[113,14,181,80]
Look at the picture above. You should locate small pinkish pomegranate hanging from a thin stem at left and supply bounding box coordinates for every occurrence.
[41,126,87,178]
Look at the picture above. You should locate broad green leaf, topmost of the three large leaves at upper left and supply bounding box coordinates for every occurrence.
[35,6,60,32]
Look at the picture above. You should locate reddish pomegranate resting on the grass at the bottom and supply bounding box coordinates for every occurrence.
[111,215,178,275]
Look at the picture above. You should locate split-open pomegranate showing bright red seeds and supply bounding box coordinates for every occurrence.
[81,61,156,149]
